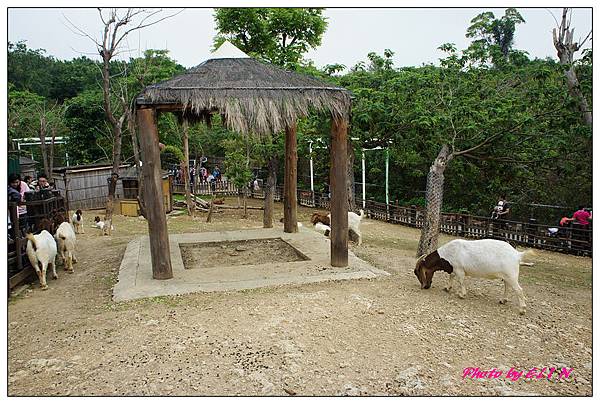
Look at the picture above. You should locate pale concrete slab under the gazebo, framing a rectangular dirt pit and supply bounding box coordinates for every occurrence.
[113,228,389,301]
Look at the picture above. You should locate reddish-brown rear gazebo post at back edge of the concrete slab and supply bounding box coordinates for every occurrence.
[283,122,298,233]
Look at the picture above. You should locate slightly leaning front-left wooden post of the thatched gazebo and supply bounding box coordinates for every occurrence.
[137,108,173,279]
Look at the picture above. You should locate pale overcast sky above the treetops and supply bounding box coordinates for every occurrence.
[8,8,592,67]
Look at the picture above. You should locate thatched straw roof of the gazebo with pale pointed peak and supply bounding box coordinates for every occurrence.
[137,42,350,134]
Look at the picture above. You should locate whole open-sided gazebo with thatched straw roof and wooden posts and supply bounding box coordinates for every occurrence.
[136,42,350,279]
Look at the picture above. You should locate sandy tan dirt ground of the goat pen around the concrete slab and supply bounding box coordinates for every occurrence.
[8,200,592,396]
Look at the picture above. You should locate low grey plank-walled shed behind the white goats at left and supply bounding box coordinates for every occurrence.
[52,163,128,210]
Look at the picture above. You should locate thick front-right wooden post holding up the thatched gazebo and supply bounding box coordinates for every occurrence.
[329,118,348,267]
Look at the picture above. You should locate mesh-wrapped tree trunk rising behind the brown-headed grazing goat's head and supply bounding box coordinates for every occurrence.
[417,145,453,257]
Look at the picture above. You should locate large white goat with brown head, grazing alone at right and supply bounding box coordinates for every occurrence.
[415,239,529,314]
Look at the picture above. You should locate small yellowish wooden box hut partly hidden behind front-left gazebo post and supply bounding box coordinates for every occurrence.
[115,167,173,216]
